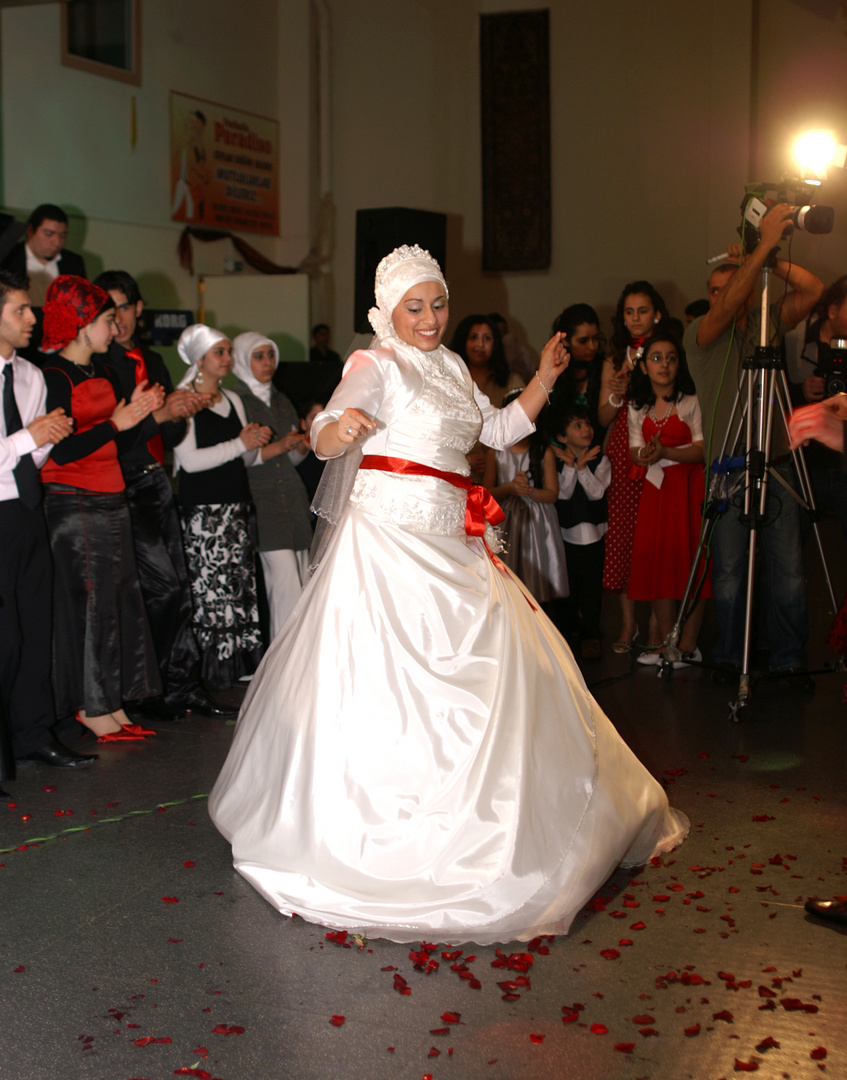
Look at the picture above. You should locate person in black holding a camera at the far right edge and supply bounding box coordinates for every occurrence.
[789,274,847,539]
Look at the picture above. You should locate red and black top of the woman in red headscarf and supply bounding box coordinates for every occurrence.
[41,355,125,494]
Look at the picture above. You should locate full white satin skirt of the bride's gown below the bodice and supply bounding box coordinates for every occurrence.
[209,505,688,944]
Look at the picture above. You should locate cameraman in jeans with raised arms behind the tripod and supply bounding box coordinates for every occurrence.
[685,203,823,690]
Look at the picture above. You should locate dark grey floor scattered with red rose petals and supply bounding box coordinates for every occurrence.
[0,524,847,1080]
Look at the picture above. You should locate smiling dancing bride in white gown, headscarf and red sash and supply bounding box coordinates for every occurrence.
[210,247,688,944]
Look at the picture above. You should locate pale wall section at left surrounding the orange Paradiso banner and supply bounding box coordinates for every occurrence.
[0,0,310,324]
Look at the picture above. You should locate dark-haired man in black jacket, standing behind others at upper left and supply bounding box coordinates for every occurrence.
[2,203,85,365]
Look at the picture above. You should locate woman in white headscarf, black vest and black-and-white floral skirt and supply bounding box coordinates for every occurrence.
[174,323,271,690]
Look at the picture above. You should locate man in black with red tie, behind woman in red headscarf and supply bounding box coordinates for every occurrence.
[95,270,238,720]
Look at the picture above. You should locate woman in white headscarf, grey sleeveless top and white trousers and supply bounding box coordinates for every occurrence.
[232,330,312,640]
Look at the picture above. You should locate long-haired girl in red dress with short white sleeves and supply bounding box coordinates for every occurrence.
[629,326,711,666]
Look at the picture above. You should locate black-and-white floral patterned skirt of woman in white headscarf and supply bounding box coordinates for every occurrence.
[179,502,261,690]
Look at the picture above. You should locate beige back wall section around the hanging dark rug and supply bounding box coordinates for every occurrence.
[324,0,750,347]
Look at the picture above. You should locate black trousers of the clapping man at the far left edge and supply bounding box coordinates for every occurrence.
[0,499,56,779]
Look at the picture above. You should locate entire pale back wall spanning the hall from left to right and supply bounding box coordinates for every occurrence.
[0,0,847,367]
